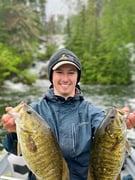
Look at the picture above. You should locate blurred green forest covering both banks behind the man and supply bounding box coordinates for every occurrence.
[0,0,135,85]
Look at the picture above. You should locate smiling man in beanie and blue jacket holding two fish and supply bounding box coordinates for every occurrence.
[2,49,135,180]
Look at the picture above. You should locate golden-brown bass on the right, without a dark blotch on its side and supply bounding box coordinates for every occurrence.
[88,107,129,180]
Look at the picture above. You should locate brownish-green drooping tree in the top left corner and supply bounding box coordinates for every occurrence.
[0,1,44,54]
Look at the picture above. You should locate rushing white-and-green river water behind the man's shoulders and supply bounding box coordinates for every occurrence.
[0,79,135,148]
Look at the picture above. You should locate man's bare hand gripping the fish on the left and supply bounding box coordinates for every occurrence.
[1,107,16,132]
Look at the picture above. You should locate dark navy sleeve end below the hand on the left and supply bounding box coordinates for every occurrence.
[2,133,17,155]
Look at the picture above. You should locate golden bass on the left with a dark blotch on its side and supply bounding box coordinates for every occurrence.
[9,102,69,180]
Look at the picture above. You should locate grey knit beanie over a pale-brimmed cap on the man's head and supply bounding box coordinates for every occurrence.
[48,48,81,83]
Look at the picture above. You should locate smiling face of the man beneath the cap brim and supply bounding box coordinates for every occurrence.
[52,64,78,98]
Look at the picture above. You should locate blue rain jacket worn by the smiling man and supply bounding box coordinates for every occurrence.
[4,90,105,180]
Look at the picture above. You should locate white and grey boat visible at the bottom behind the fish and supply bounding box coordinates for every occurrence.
[0,148,135,180]
